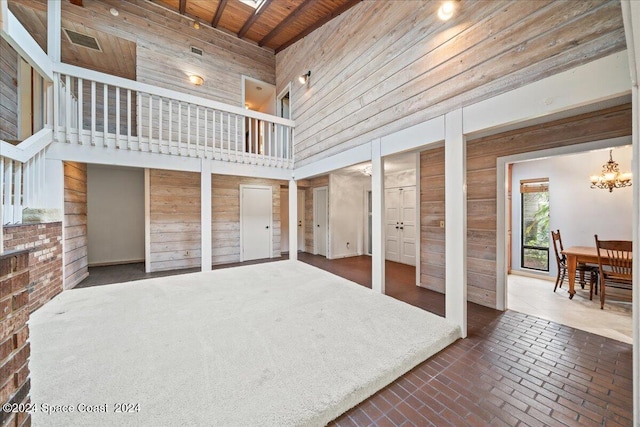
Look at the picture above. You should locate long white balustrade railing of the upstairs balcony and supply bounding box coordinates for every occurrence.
[54,64,294,168]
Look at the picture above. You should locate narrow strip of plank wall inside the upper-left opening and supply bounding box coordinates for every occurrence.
[0,37,19,141]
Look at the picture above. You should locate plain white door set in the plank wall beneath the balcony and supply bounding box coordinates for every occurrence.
[240,186,272,261]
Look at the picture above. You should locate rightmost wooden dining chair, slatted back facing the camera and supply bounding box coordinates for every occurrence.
[595,234,633,309]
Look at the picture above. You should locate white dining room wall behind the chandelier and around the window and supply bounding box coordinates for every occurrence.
[512,146,637,277]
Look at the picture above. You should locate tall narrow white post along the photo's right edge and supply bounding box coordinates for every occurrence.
[621,0,640,426]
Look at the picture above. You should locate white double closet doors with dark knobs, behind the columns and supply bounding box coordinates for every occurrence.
[384,186,416,265]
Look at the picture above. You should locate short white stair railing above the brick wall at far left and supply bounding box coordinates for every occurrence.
[0,128,52,225]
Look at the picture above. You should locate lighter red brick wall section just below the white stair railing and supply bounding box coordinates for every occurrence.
[3,222,62,313]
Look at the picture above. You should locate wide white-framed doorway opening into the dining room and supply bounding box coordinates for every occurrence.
[497,138,632,342]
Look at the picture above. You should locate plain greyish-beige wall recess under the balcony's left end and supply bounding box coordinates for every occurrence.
[87,164,145,265]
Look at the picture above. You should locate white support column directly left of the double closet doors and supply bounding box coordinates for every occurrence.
[371,139,385,294]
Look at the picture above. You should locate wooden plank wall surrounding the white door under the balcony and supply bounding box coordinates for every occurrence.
[211,175,288,264]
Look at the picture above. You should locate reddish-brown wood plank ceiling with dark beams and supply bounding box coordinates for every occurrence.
[150,0,362,53]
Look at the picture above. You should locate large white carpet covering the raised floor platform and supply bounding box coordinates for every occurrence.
[29,261,460,426]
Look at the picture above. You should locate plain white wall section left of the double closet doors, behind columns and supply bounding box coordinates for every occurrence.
[329,174,371,258]
